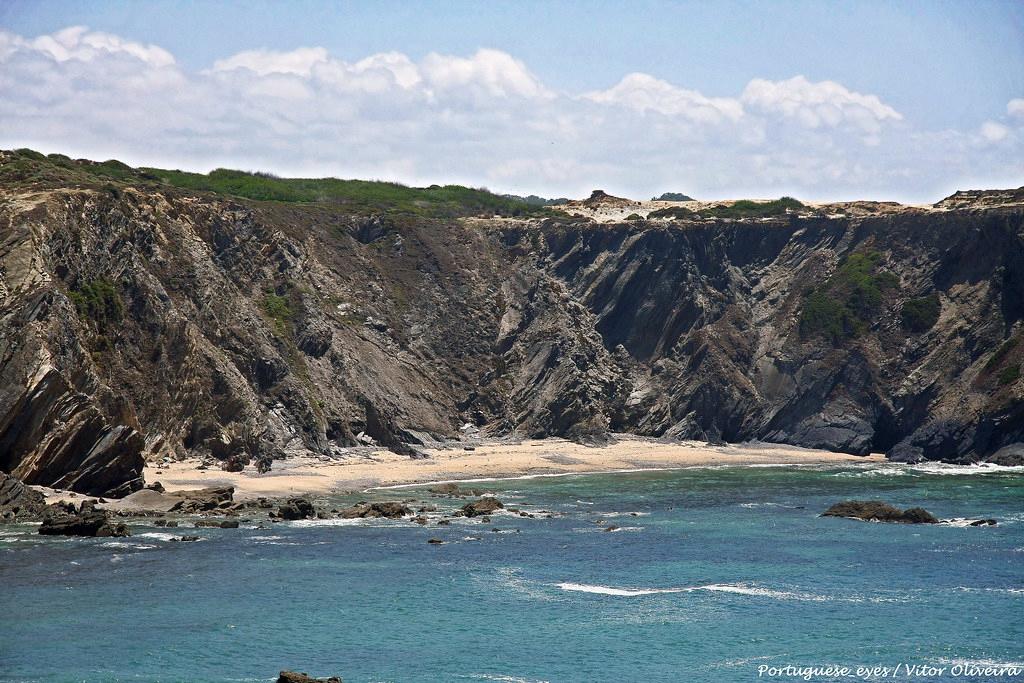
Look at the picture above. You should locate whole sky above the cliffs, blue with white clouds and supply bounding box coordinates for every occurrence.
[0,0,1024,203]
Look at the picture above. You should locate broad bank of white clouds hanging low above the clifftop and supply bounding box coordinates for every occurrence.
[0,27,1024,200]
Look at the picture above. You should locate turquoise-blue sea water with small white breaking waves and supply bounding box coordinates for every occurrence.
[0,465,1024,683]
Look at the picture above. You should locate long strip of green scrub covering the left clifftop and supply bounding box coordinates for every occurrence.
[0,150,552,218]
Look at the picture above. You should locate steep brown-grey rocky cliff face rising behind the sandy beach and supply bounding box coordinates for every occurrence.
[0,153,1024,495]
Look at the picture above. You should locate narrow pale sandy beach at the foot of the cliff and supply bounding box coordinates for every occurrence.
[145,439,885,499]
